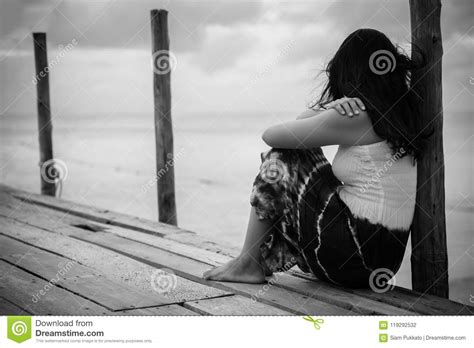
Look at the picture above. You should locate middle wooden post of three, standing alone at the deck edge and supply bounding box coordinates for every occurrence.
[151,10,177,225]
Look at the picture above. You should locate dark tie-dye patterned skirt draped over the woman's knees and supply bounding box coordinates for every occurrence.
[250,148,409,288]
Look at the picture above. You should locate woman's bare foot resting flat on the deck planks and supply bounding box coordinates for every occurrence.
[203,256,265,283]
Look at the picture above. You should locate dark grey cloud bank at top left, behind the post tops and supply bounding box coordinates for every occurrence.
[0,0,262,52]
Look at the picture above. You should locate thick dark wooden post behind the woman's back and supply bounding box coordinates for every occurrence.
[410,0,449,298]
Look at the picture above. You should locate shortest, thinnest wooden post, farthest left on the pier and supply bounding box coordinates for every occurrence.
[33,33,56,196]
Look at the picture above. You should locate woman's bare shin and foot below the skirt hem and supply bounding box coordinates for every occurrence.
[203,207,272,283]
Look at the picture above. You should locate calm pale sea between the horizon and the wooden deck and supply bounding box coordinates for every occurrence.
[0,112,474,303]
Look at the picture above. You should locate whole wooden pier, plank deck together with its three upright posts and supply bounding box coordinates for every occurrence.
[19,0,452,306]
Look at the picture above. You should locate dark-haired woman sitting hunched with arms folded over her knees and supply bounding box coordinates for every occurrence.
[204,29,425,287]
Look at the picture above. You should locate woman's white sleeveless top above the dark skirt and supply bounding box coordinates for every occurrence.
[332,140,417,230]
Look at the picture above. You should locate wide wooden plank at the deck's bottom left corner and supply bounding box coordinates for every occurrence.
[0,261,110,315]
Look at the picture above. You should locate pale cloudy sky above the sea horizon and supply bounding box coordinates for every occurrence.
[0,0,474,115]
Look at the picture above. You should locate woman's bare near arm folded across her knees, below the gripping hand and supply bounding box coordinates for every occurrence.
[262,109,382,149]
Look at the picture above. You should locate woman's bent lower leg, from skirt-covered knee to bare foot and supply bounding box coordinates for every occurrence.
[203,148,329,283]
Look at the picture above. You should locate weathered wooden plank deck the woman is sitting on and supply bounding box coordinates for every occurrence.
[0,185,474,315]
